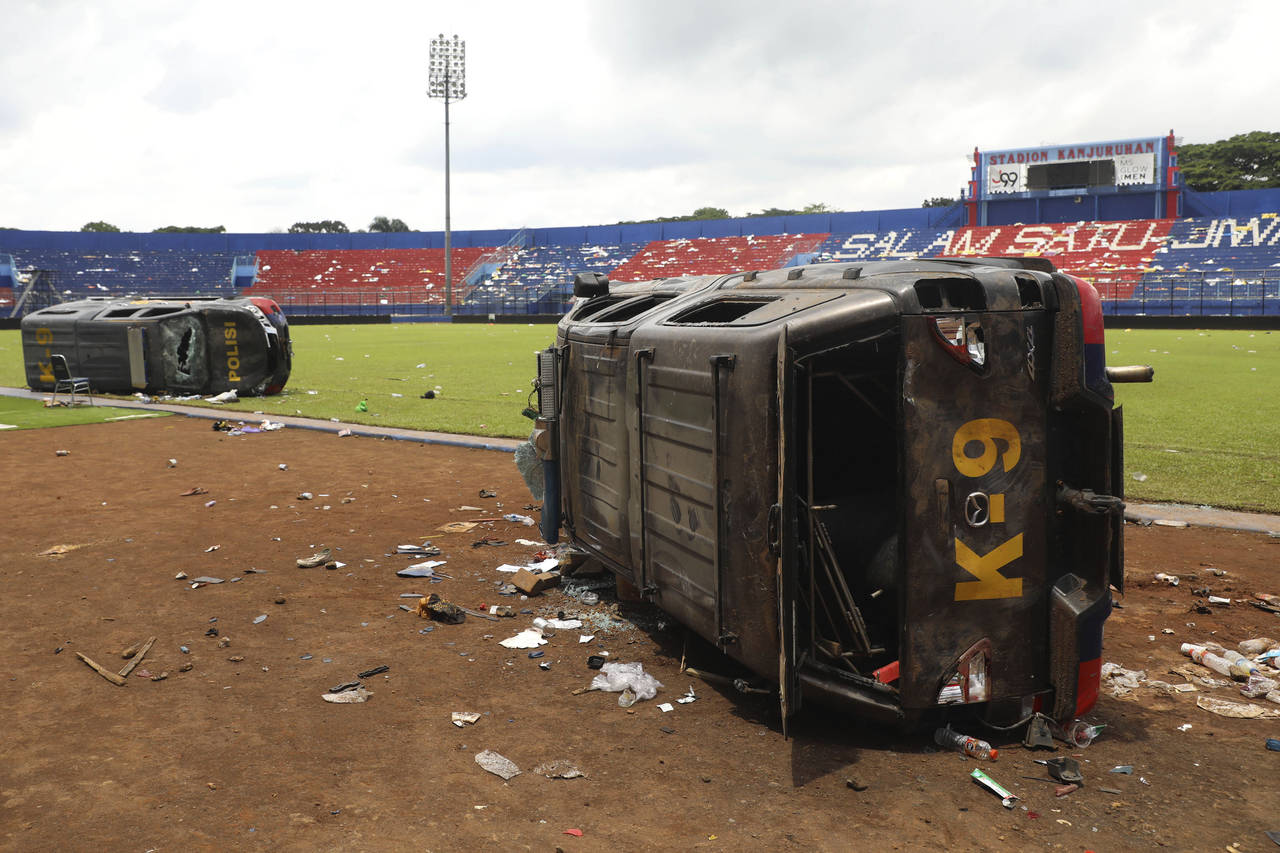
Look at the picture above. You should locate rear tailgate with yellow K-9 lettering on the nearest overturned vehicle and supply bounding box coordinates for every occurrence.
[900,310,1052,708]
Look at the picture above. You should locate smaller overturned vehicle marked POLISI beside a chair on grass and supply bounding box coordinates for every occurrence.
[22,297,292,396]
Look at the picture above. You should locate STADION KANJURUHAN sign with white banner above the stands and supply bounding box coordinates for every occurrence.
[978,137,1165,196]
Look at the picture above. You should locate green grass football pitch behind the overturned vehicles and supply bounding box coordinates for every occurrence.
[0,323,1280,512]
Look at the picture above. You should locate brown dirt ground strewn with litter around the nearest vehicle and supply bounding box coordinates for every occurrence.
[0,418,1280,852]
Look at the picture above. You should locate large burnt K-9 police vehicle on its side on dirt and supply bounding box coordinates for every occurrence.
[534,259,1149,725]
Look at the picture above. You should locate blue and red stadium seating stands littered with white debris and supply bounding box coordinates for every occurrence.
[0,190,1280,319]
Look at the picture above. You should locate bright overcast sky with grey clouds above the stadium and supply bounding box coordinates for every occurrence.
[0,0,1280,232]
